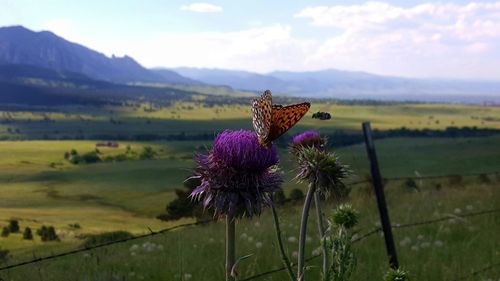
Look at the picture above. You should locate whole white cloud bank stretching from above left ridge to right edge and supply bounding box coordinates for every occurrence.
[47,2,500,80]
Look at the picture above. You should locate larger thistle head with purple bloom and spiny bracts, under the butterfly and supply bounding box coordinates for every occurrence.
[191,130,283,217]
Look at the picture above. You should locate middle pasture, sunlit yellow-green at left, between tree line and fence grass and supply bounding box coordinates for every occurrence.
[0,136,500,266]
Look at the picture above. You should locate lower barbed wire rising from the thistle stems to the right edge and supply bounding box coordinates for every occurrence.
[240,208,500,281]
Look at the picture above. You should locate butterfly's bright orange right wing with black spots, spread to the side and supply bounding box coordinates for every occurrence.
[265,102,311,143]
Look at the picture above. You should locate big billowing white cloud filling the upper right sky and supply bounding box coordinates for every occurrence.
[295,2,500,79]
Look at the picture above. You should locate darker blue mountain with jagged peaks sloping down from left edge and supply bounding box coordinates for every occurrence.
[0,26,190,83]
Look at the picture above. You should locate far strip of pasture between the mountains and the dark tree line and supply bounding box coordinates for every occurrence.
[0,99,500,139]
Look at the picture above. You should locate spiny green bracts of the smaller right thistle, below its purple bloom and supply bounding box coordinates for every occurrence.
[295,146,350,197]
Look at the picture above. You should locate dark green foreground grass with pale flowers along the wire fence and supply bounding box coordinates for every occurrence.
[2,178,500,280]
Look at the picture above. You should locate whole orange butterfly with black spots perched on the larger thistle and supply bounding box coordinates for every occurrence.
[252,90,311,147]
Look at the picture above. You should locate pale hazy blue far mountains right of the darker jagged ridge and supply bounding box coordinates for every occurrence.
[174,68,500,102]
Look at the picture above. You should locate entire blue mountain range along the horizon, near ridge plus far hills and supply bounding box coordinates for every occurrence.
[0,26,500,102]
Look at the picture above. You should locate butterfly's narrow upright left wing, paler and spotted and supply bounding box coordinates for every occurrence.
[252,90,273,143]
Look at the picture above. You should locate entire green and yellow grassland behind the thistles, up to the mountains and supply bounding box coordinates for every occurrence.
[0,99,500,280]
